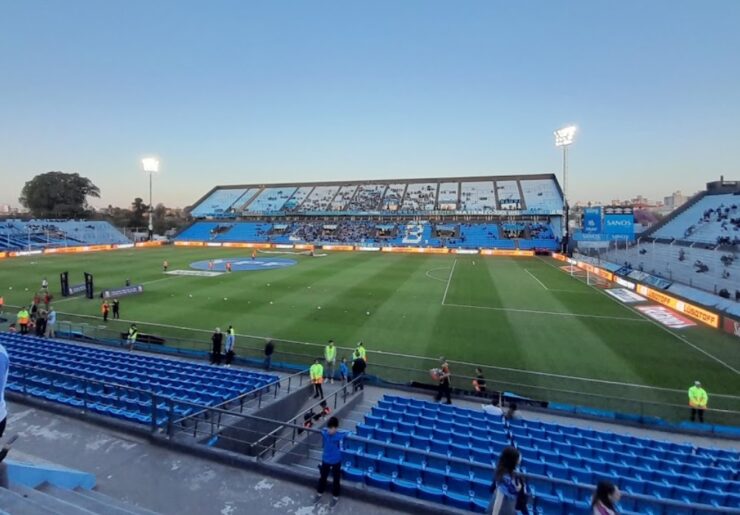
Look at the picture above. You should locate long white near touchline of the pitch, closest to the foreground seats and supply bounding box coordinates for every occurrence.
[49,304,740,399]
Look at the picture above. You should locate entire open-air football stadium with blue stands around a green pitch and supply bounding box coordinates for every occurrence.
[0,169,740,514]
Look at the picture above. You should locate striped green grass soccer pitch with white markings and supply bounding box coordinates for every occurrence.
[0,247,740,422]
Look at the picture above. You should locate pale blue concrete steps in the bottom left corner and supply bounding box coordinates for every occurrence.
[0,482,156,515]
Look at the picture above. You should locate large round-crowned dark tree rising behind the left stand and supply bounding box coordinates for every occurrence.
[18,172,100,218]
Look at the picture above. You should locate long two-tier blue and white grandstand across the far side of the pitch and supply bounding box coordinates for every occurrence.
[182,175,563,250]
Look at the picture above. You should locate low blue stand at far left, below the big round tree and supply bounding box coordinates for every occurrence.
[0,219,131,251]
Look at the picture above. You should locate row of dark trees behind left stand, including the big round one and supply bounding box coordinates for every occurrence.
[18,171,188,234]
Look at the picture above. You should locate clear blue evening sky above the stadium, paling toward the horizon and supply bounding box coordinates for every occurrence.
[0,0,740,210]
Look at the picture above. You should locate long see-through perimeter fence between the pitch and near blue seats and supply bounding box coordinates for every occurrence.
[26,312,740,426]
